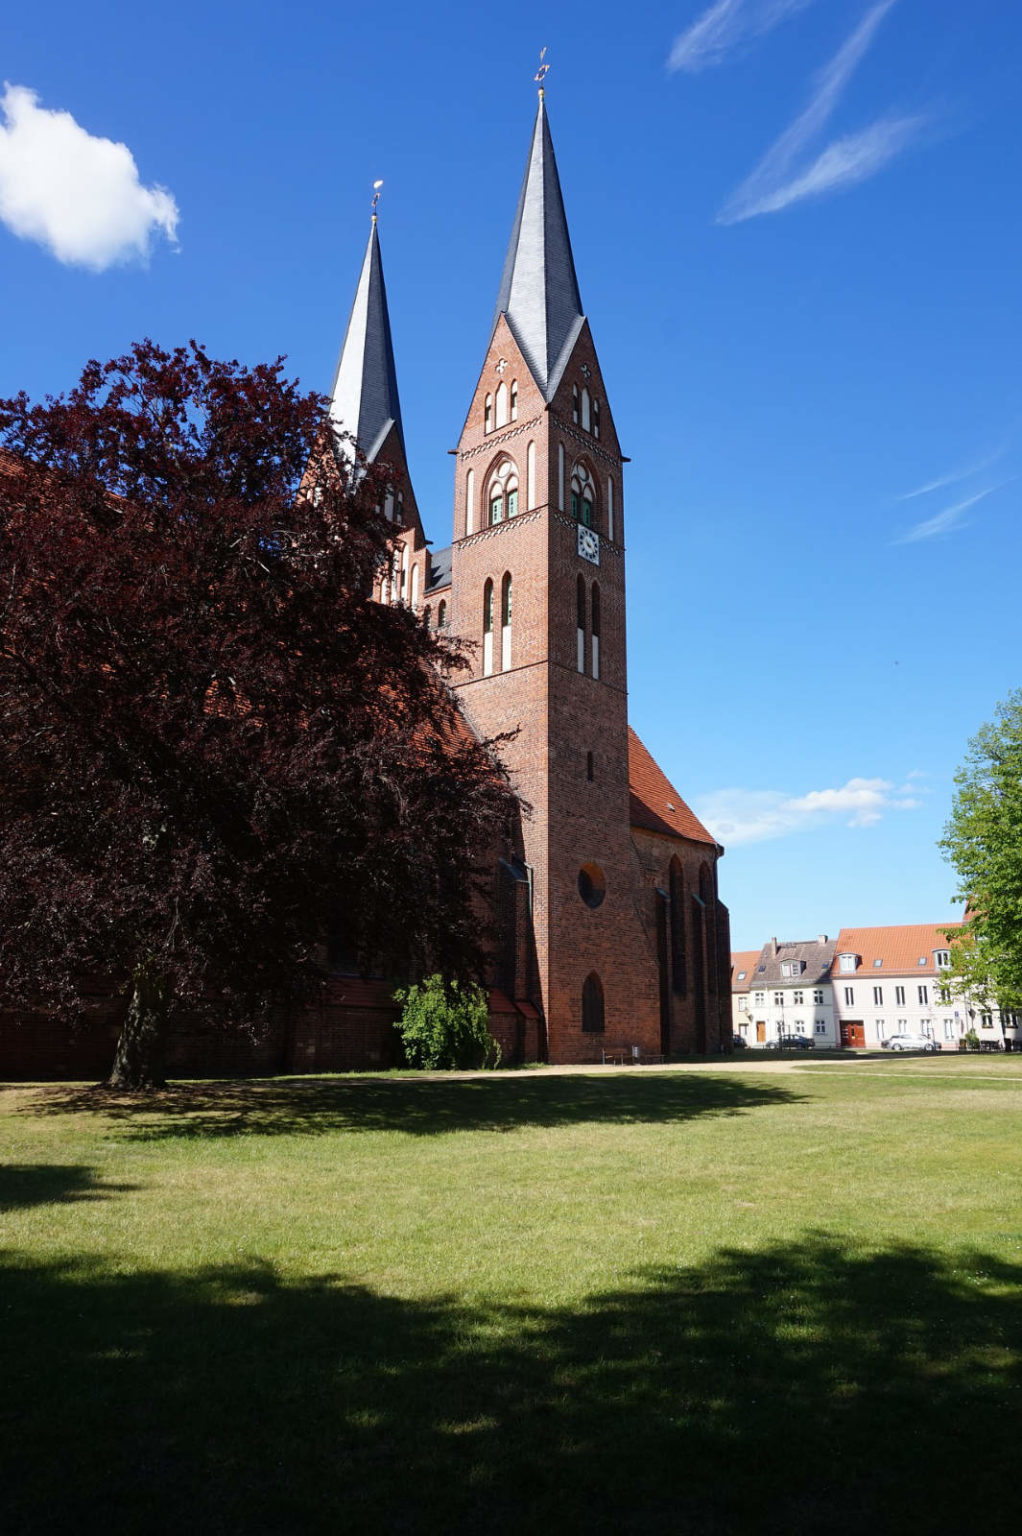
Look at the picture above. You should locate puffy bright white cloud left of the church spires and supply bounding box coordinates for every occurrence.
[0,84,178,272]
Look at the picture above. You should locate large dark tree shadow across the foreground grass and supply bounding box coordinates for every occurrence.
[0,1236,1022,1536]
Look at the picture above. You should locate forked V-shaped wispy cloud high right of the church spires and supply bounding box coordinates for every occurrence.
[718,0,928,224]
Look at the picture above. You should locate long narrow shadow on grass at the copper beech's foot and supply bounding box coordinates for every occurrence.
[23,1069,802,1140]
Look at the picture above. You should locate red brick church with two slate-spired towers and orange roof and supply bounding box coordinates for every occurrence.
[324,91,732,1061]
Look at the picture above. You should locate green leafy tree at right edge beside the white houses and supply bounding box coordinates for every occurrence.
[941,690,1022,1008]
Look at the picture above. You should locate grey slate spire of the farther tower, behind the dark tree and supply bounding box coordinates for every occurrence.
[330,214,404,462]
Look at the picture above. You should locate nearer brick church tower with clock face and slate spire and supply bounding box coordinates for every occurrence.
[450,91,665,1061]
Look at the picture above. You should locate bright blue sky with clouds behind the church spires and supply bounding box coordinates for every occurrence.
[0,0,1022,948]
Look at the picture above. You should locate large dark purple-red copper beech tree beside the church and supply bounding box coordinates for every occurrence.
[0,341,513,1089]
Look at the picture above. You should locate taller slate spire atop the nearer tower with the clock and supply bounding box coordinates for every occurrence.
[493,91,582,399]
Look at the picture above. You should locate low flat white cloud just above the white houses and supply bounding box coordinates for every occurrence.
[695,776,921,848]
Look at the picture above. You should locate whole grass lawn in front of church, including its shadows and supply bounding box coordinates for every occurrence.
[0,1057,1022,1536]
